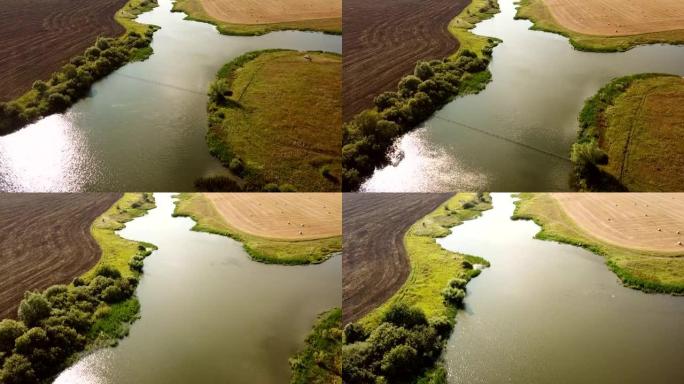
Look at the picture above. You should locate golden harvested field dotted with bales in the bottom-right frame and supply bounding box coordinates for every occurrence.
[553,193,684,252]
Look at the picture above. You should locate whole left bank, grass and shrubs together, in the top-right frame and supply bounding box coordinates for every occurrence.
[342,0,500,191]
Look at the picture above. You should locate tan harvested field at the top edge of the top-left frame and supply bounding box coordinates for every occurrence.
[200,0,342,24]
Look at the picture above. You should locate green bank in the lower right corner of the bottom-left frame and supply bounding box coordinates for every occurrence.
[290,308,342,384]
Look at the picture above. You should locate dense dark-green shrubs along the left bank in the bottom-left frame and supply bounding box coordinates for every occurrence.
[0,266,143,384]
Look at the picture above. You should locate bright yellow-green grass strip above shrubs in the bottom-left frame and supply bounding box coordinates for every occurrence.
[82,193,156,280]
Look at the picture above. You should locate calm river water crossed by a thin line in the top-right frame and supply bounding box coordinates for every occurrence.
[362,0,684,192]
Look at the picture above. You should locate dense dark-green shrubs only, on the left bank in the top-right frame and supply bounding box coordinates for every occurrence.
[342,50,491,191]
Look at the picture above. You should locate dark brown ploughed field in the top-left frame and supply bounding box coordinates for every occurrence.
[0,0,127,101]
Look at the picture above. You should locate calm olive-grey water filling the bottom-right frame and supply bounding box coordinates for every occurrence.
[439,194,684,384]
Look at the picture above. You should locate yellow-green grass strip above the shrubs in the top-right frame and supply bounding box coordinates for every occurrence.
[448,0,501,60]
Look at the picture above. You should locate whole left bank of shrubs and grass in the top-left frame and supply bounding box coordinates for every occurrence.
[0,0,158,135]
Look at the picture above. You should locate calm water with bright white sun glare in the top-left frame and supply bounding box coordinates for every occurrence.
[0,0,342,191]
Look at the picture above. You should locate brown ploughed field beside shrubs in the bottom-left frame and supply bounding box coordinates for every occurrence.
[0,193,121,319]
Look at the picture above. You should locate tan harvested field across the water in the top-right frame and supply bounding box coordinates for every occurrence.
[544,0,684,36]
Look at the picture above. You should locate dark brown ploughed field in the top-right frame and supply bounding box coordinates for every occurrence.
[342,0,470,121]
